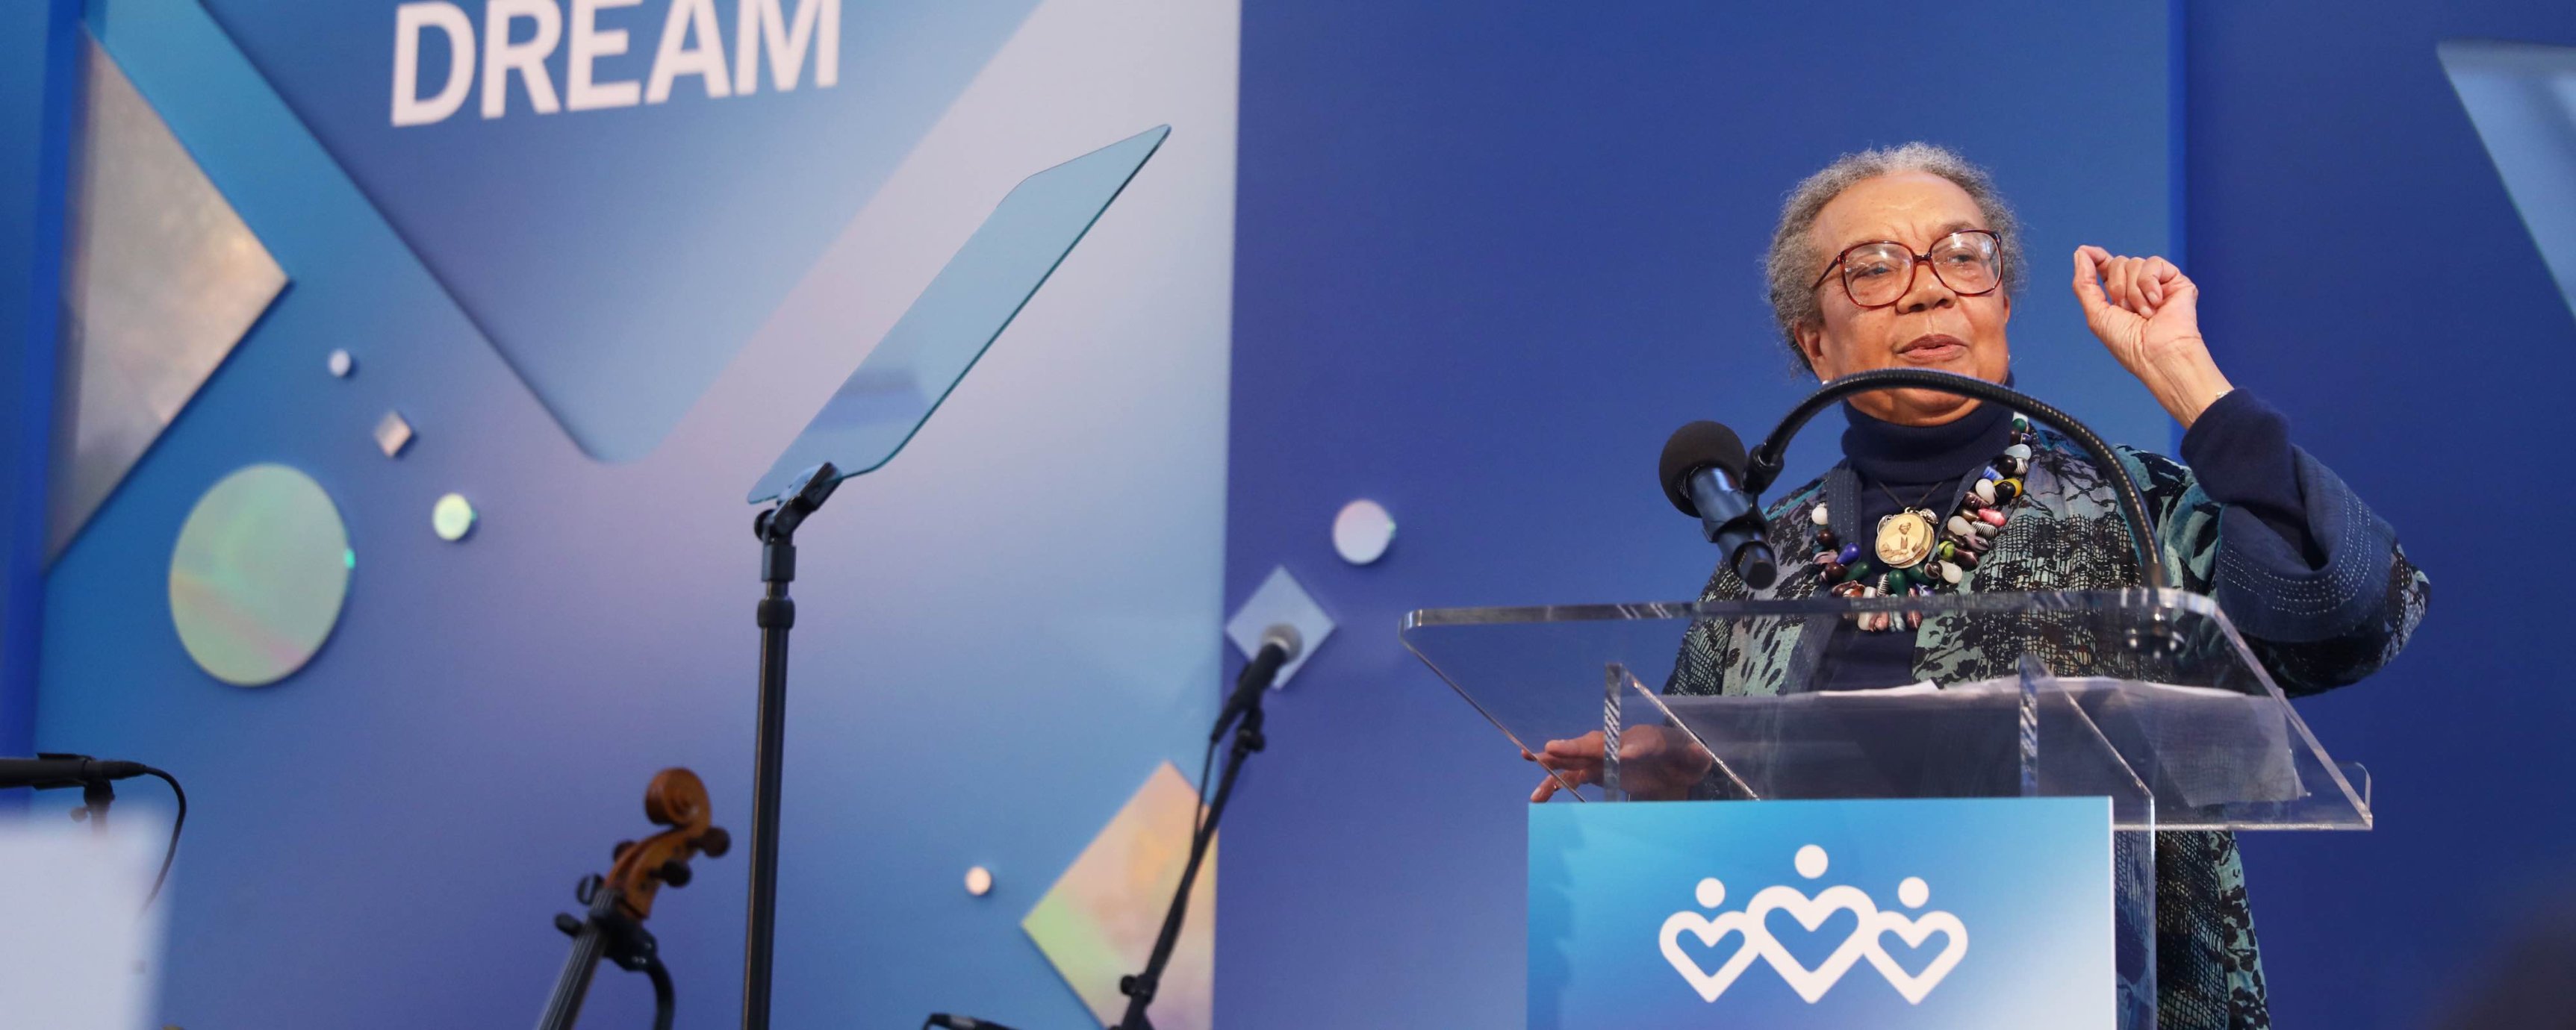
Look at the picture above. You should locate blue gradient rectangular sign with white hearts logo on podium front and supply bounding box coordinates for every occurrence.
[1530,799,2115,1030]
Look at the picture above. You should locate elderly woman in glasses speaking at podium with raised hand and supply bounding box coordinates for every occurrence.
[1533,144,2427,1028]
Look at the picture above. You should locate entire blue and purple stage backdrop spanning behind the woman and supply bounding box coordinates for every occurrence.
[0,0,2576,1030]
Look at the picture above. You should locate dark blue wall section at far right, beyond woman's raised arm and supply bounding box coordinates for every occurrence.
[2187,2,2576,1028]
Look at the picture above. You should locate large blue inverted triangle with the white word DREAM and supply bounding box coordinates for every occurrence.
[204,0,1036,461]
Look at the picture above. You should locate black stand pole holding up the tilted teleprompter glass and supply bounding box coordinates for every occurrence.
[742,461,840,1030]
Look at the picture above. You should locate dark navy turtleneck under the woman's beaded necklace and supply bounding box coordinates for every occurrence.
[1816,405,2012,690]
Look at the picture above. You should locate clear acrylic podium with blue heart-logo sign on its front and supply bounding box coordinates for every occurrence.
[1404,590,2370,1030]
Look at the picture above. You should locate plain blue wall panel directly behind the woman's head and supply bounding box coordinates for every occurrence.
[1216,0,2171,1030]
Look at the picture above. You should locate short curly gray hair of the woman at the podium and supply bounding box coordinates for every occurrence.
[1762,142,2022,371]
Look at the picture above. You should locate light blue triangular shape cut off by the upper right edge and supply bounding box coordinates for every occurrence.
[2434,39,2576,322]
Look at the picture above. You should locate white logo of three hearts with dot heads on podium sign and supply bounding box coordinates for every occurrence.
[1659,845,1968,1005]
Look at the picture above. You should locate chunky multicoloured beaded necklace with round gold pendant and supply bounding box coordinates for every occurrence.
[1814,414,2040,634]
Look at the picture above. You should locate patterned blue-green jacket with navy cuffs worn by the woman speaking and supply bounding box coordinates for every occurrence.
[1667,402,2429,1030]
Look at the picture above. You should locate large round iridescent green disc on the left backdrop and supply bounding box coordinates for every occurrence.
[170,464,358,687]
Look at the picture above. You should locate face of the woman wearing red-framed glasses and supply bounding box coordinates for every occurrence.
[1798,172,2012,425]
